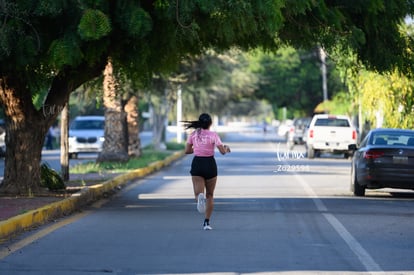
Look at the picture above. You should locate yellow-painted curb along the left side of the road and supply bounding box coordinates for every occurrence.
[0,151,184,243]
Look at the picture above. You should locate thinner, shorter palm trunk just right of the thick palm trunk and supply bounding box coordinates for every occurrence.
[124,95,142,157]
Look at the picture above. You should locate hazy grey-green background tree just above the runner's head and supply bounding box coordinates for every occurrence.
[180,50,257,120]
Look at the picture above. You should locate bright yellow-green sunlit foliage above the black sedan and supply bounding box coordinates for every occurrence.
[332,18,414,136]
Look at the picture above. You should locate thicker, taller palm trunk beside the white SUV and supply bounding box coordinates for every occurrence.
[97,59,129,162]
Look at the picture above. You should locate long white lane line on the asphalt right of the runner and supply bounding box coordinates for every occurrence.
[294,174,383,272]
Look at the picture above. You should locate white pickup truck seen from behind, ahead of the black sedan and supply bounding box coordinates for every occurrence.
[305,114,357,158]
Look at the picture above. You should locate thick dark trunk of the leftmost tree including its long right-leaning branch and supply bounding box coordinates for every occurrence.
[0,63,105,196]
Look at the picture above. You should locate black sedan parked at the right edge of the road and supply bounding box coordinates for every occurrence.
[349,128,414,196]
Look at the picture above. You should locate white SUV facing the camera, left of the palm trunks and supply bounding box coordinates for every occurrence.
[69,116,105,158]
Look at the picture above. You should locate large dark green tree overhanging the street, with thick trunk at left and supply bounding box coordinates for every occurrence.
[0,0,414,195]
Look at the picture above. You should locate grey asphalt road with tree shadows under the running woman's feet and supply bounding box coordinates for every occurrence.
[0,134,414,275]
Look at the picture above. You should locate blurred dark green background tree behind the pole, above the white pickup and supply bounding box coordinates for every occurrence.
[249,47,340,117]
